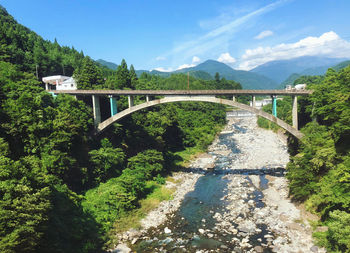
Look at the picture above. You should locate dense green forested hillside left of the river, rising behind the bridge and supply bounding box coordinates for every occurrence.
[0,5,241,253]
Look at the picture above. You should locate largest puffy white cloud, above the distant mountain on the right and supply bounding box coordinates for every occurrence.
[239,31,350,70]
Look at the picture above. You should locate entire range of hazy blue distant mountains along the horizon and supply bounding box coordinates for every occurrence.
[97,56,350,89]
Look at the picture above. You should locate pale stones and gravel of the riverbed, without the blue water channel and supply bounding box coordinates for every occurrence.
[110,117,325,252]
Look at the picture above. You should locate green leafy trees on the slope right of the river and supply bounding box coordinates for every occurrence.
[259,66,350,252]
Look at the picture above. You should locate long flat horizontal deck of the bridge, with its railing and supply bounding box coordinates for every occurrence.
[49,90,313,96]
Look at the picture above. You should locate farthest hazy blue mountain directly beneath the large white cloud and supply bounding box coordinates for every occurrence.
[251,56,346,83]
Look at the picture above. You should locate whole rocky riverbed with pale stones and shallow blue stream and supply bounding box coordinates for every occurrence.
[110,117,325,252]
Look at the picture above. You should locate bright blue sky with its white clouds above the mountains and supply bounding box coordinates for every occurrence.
[0,0,350,70]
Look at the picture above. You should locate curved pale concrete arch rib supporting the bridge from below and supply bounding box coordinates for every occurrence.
[97,96,304,139]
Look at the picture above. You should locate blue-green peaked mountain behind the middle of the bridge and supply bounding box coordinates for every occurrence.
[175,60,278,89]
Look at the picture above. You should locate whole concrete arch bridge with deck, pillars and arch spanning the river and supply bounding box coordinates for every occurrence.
[50,90,312,139]
